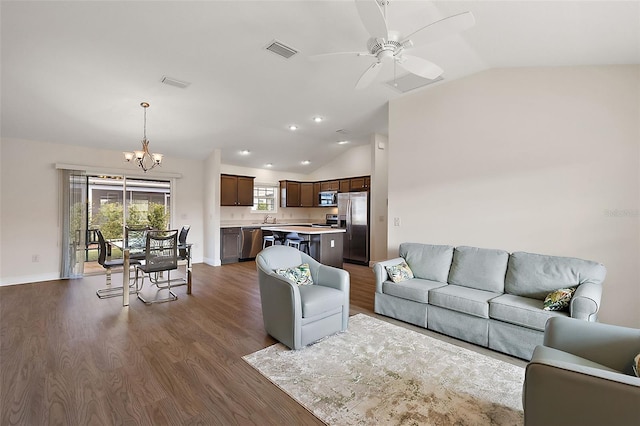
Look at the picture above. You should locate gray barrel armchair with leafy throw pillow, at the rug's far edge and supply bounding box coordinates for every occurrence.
[256,246,350,349]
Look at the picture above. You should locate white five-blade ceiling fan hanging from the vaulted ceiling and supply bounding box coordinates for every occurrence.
[313,0,475,89]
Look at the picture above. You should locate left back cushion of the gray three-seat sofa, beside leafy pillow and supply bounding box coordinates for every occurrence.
[399,243,453,283]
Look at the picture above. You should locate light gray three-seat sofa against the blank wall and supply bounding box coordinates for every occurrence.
[373,243,606,360]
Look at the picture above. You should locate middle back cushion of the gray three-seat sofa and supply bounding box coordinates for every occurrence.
[448,247,508,293]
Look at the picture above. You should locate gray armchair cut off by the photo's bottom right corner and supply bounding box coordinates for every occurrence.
[522,317,640,426]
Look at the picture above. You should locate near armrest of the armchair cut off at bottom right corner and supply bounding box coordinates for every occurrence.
[522,351,640,426]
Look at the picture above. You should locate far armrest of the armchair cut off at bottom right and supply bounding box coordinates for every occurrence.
[544,317,640,374]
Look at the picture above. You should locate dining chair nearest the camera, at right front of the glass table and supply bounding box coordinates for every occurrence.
[135,229,178,304]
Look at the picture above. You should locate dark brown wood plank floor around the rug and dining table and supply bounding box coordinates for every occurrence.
[0,262,374,425]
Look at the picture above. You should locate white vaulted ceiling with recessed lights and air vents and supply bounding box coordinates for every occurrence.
[0,0,640,173]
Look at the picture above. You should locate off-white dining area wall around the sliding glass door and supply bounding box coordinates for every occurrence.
[0,138,203,285]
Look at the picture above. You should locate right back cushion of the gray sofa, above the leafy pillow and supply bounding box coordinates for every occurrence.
[504,252,607,300]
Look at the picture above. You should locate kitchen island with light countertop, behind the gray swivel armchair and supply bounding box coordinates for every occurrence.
[262,225,346,268]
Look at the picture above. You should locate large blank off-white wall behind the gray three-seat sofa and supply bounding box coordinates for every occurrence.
[388,66,640,327]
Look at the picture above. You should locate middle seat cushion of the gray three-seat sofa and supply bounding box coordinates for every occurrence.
[429,284,500,318]
